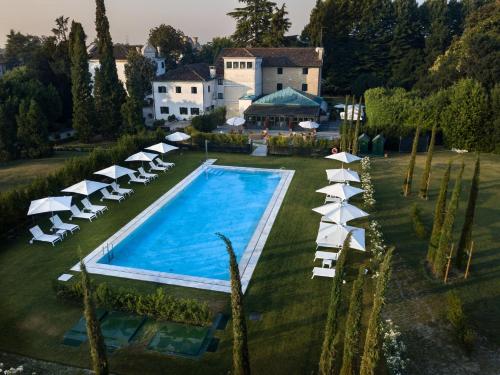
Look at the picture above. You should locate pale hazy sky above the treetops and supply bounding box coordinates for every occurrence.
[0,0,316,46]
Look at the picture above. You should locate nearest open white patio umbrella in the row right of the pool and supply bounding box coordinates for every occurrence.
[316,222,365,251]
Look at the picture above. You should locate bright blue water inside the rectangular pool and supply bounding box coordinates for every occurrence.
[98,167,281,280]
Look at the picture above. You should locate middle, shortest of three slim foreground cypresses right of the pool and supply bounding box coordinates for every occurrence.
[340,267,365,375]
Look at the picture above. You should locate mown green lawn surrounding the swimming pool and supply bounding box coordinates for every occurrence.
[0,152,500,374]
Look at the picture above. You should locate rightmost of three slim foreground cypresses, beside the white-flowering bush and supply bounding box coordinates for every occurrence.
[359,248,394,375]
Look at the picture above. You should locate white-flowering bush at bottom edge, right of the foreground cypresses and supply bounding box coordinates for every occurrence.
[382,319,408,375]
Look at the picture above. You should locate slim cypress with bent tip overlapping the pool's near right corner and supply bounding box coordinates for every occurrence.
[217,233,250,375]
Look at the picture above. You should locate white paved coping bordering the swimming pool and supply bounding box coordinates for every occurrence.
[71,159,295,293]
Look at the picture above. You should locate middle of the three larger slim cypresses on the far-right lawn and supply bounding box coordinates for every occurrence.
[433,161,465,278]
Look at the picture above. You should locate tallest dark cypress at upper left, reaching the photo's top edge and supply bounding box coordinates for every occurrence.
[94,0,125,138]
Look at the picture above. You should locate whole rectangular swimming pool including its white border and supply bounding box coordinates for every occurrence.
[74,160,293,292]
